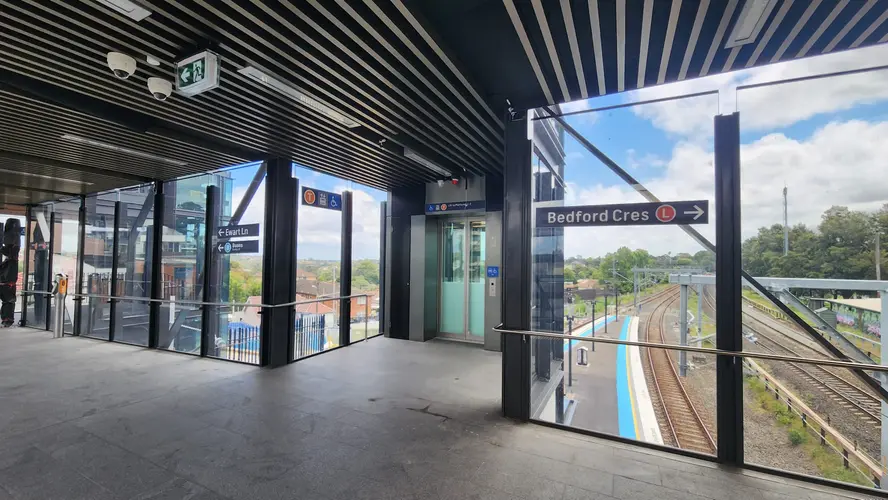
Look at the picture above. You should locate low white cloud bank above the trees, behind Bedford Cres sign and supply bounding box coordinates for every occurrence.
[565,120,888,256]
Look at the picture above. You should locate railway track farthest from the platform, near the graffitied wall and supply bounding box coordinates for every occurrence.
[703,292,882,427]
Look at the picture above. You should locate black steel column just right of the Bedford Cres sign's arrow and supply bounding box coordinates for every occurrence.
[715,113,743,465]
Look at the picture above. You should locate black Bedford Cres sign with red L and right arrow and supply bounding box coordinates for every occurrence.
[536,200,709,227]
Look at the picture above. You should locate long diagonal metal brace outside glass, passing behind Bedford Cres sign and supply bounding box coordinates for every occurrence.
[542,106,888,402]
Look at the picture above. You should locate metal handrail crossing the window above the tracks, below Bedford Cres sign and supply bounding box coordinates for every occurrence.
[493,323,888,372]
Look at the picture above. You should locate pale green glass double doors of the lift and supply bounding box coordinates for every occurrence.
[438,217,487,342]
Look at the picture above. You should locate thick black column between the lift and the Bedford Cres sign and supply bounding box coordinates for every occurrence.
[502,112,533,420]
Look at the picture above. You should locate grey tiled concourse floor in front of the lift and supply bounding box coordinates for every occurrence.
[0,329,876,500]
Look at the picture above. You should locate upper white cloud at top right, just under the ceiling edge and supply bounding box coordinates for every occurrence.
[626,45,888,137]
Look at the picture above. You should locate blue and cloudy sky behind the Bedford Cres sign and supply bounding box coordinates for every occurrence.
[548,45,888,257]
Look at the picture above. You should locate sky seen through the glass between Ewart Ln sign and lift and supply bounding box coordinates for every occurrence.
[232,165,386,260]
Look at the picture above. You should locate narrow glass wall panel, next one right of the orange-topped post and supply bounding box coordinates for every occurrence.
[80,192,117,339]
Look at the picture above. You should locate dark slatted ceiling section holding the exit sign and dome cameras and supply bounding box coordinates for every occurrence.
[0,0,503,205]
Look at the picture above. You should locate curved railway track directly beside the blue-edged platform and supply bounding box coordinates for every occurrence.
[645,289,716,453]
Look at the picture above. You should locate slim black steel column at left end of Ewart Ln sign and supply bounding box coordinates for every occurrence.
[200,186,221,356]
